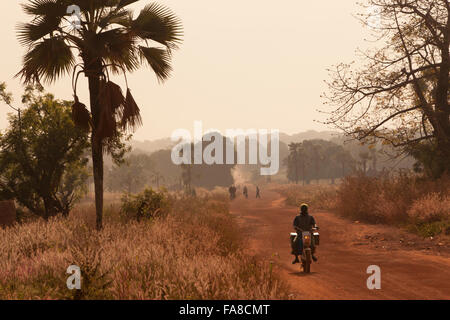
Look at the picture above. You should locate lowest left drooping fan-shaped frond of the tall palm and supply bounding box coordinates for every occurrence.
[16,37,75,83]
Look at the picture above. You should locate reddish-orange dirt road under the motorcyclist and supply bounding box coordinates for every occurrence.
[231,190,450,299]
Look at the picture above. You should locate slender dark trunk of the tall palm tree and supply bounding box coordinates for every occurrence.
[88,63,103,230]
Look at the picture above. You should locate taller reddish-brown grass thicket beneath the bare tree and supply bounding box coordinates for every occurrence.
[336,174,450,236]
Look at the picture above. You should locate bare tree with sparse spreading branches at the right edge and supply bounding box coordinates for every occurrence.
[325,0,450,173]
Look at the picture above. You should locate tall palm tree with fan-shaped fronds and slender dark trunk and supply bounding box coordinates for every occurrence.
[18,0,182,229]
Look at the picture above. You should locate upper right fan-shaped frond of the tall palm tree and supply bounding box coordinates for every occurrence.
[130,3,183,49]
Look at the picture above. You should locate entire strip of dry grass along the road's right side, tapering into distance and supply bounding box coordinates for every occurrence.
[276,173,450,237]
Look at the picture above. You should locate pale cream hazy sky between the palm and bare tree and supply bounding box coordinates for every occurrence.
[0,0,365,140]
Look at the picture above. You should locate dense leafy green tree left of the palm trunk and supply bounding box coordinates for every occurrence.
[0,83,89,219]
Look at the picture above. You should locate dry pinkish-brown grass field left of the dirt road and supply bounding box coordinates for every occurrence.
[0,193,287,299]
